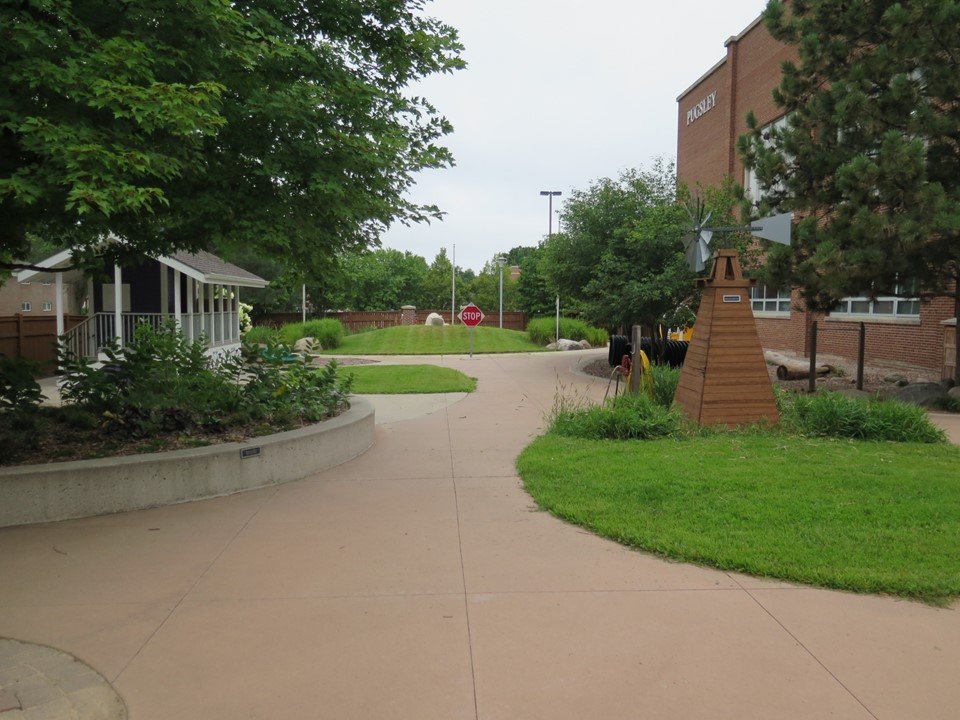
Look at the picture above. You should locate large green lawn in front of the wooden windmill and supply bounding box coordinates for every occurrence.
[517,433,960,604]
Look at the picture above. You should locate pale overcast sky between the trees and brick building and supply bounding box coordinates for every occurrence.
[382,0,766,271]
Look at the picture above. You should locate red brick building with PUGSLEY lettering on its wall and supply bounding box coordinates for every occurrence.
[677,18,956,377]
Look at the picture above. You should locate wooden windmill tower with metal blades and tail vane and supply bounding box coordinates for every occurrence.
[674,202,792,426]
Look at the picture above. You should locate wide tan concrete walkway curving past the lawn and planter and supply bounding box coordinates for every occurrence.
[0,351,960,720]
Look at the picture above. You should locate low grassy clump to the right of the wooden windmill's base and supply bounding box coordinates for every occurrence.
[778,392,946,443]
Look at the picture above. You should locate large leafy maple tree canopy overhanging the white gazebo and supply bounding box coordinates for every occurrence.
[0,0,463,277]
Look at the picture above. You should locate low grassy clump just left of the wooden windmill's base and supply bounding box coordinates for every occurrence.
[550,393,683,440]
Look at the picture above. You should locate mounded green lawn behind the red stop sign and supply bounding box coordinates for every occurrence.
[324,325,543,355]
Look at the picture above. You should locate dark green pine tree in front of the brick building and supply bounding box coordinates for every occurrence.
[739,0,960,381]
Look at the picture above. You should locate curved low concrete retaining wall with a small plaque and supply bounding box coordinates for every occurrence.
[0,396,374,527]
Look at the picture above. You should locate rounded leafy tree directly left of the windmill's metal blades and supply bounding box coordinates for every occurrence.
[544,161,694,328]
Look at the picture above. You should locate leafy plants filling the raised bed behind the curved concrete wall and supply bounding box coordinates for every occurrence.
[61,322,350,438]
